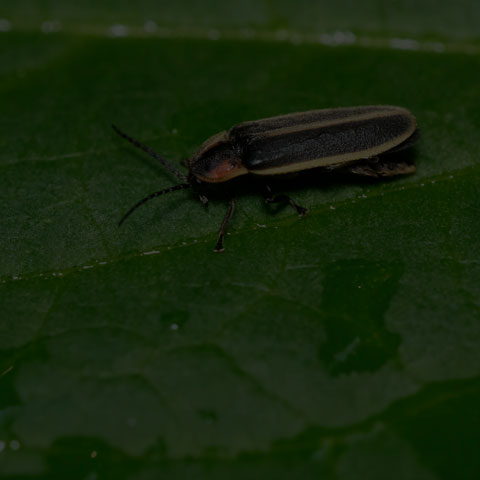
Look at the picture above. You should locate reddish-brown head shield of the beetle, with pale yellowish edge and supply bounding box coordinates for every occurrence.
[188,132,248,184]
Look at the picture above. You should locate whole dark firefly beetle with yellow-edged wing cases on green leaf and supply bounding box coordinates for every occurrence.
[112,105,418,252]
